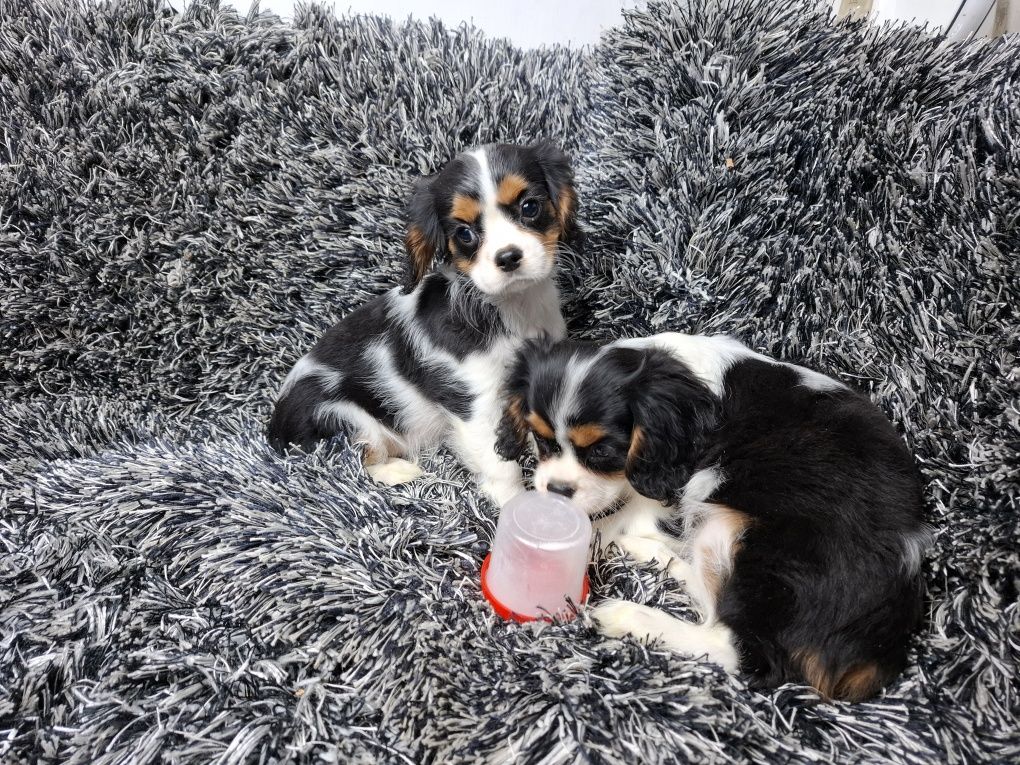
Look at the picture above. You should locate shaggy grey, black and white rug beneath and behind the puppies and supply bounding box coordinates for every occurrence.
[0,0,1020,765]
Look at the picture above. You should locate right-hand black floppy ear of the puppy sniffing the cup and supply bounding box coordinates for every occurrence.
[625,349,718,504]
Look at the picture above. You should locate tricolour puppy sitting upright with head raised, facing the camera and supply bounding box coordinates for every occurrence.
[268,142,576,503]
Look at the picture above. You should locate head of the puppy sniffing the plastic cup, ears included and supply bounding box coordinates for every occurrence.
[497,341,716,513]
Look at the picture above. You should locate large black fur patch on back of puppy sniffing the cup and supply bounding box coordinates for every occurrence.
[702,359,925,700]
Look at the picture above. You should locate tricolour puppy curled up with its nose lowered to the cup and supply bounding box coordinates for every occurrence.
[497,333,928,701]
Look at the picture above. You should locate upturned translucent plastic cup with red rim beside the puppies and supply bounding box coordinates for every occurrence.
[481,492,592,621]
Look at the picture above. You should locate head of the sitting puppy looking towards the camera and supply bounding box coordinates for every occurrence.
[406,142,576,296]
